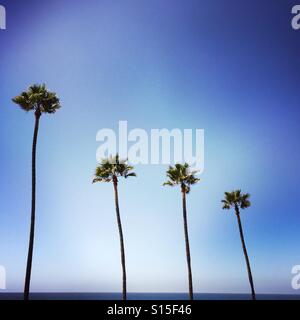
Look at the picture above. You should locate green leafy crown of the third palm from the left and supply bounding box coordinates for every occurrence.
[163,163,200,193]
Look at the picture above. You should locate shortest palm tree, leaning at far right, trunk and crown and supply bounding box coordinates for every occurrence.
[222,190,256,300]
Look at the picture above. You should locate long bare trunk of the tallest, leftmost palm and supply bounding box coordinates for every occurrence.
[24,110,41,300]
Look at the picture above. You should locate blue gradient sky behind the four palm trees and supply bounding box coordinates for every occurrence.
[0,0,300,293]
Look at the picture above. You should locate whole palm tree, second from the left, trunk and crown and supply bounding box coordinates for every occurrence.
[93,154,136,300]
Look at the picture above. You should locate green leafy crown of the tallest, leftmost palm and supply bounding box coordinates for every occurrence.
[12,84,61,114]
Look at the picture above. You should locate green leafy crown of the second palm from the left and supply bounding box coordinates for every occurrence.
[93,154,136,183]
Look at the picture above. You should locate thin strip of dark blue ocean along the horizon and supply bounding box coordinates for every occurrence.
[0,292,300,300]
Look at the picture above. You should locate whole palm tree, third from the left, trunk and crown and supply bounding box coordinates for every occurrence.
[164,163,200,300]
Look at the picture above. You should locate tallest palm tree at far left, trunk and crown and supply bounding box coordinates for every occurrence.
[12,84,61,300]
